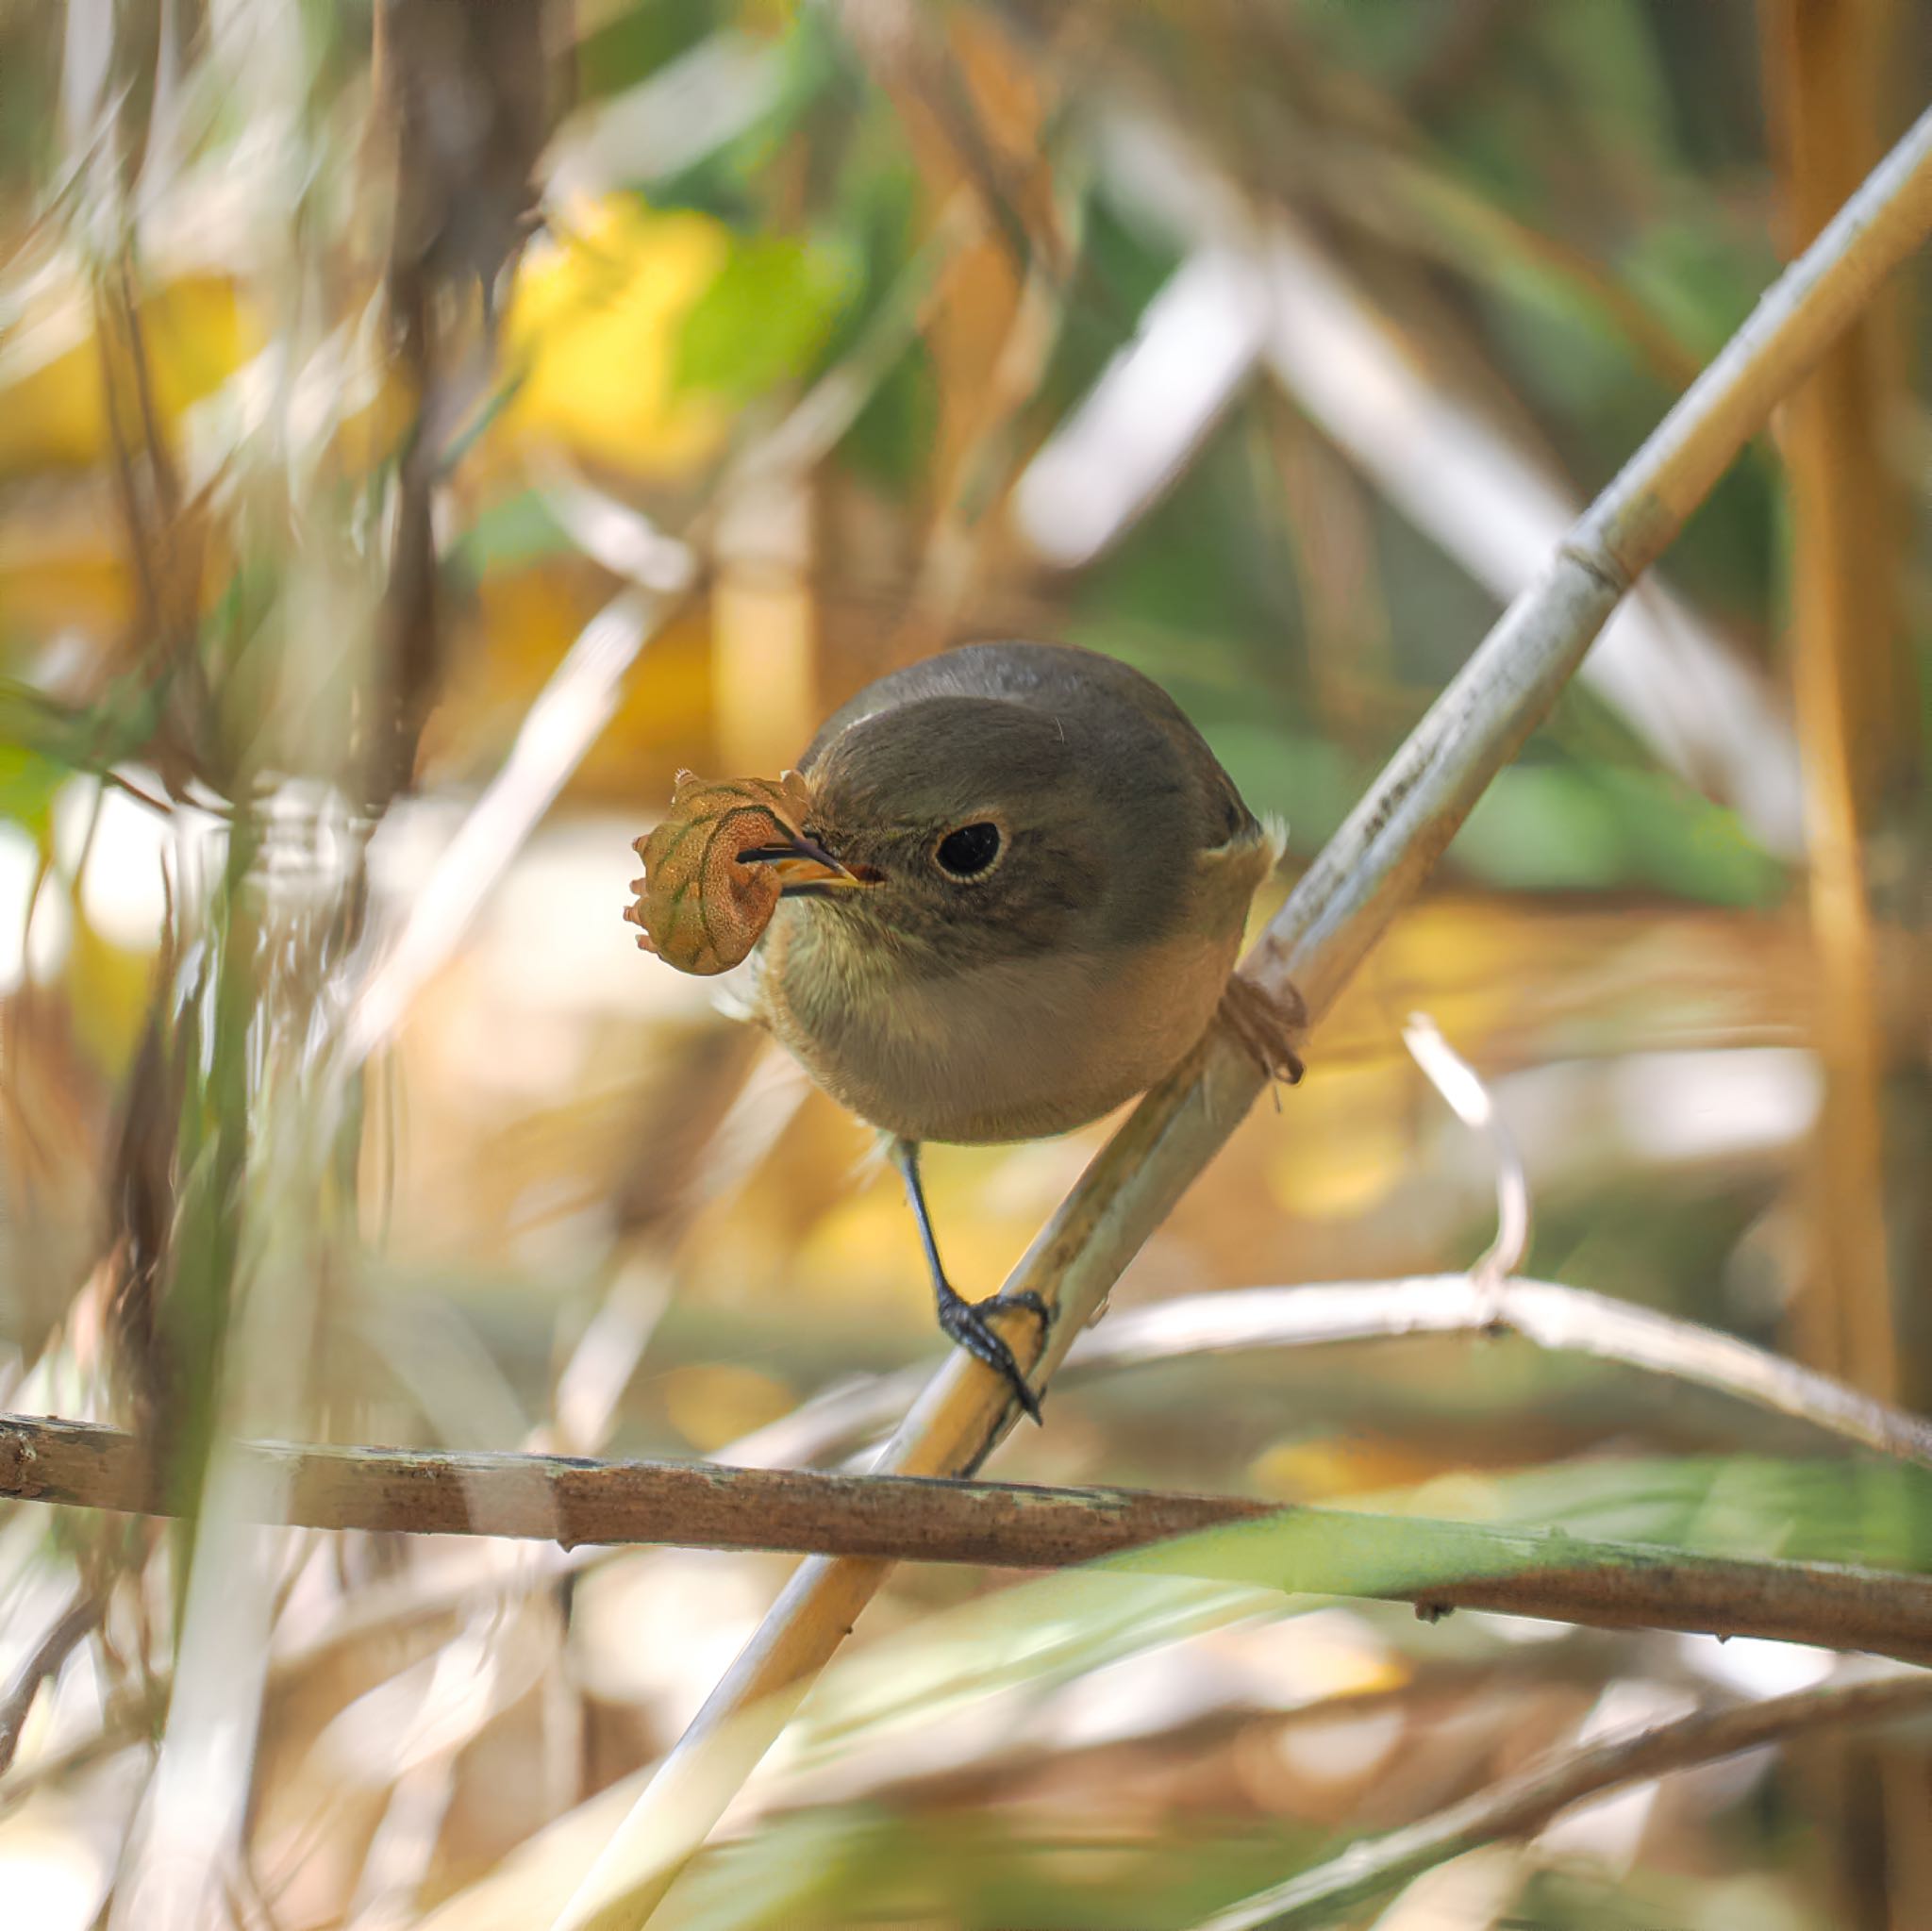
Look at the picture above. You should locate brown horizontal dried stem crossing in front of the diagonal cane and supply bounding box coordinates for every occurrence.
[0,1415,1932,1658]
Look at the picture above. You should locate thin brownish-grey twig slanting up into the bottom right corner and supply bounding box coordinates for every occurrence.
[1198,1671,1932,1931]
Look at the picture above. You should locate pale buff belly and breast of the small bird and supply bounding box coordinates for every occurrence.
[758,907,1241,1141]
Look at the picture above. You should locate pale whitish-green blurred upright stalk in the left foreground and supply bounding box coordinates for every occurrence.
[66,0,547,1931]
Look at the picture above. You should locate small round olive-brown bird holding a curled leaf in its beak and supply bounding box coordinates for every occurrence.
[738,643,1300,1422]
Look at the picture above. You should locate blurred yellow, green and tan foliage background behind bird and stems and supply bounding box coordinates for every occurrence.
[0,0,1932,1931]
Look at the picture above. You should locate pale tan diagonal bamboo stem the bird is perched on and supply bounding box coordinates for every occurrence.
[557,101,1932,1931]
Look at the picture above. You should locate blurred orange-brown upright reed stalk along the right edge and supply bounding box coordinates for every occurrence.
[1762,0,1932,1931]
